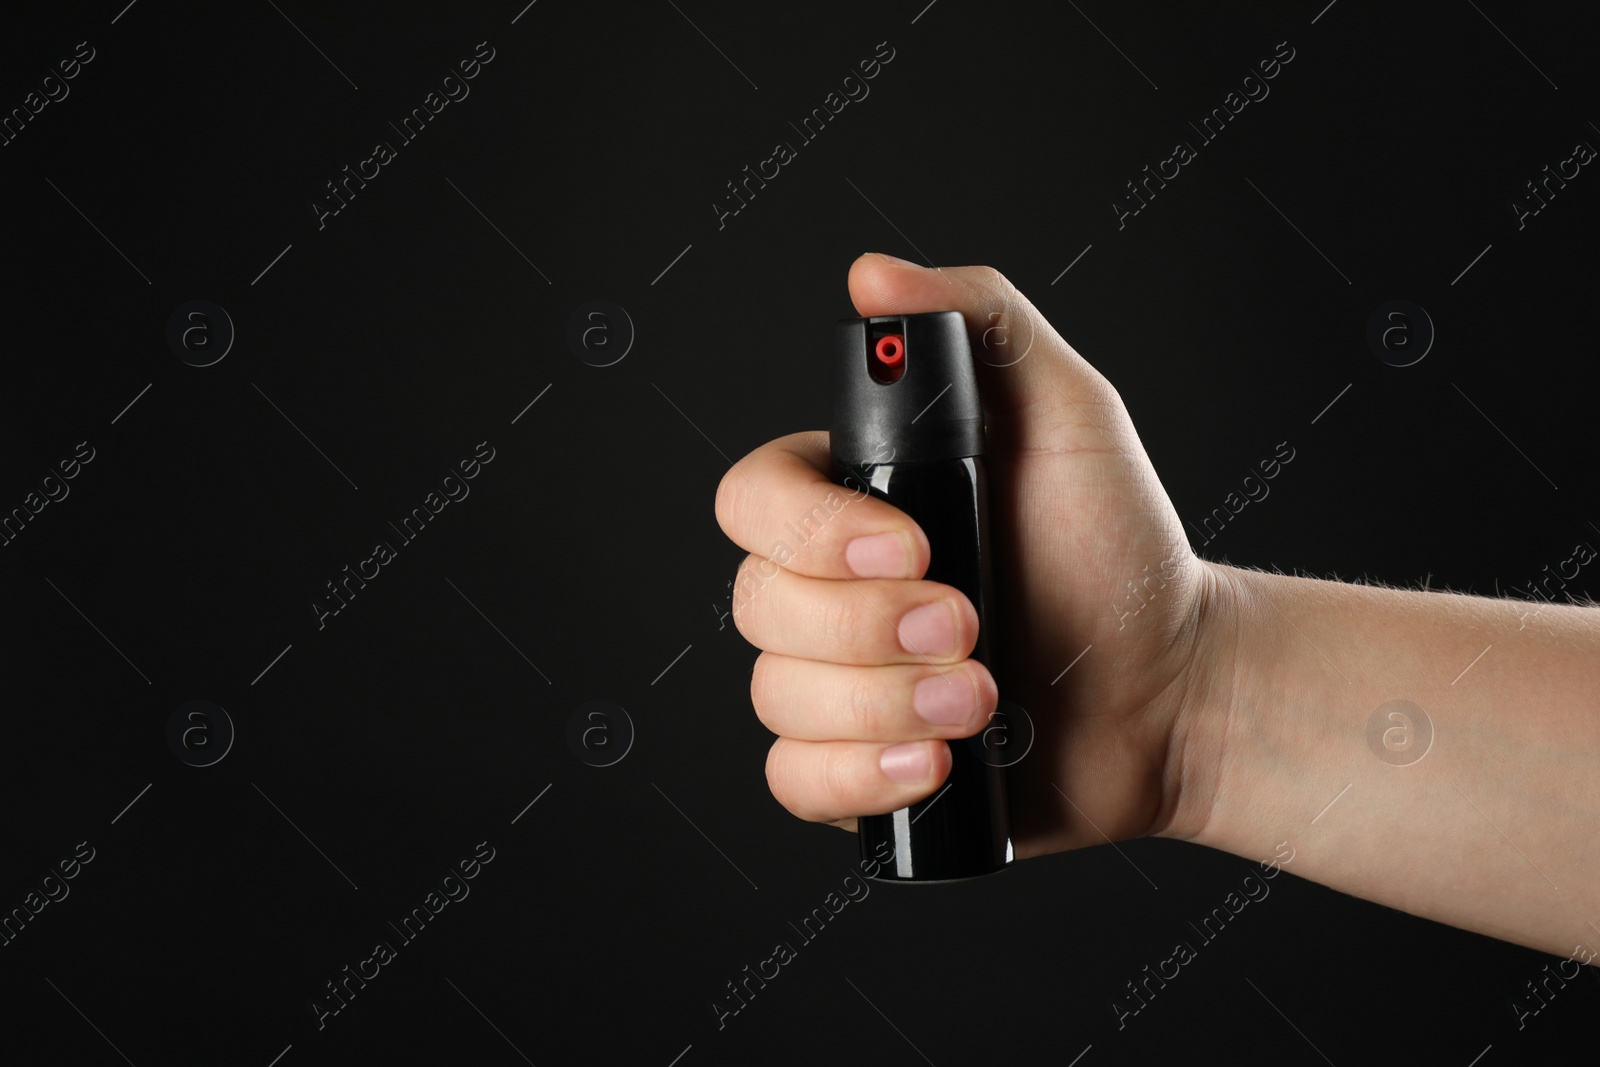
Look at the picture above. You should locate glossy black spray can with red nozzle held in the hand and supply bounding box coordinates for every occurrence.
[829,312,1011,881]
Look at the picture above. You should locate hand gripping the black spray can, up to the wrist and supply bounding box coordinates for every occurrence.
[717,254,1227,857]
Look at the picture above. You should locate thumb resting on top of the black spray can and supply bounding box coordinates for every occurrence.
[850,253,1133,451]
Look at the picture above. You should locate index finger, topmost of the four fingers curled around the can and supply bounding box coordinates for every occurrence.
[717,430,928,579]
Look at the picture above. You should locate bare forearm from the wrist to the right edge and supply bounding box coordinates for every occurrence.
[1186,565,1600,958]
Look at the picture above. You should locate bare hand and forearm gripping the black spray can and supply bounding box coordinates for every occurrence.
[715,254,1600,963]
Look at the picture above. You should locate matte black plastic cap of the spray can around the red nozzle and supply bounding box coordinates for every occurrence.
[829,303,984,467]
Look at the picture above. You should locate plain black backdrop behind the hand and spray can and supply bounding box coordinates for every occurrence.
[0,0,1600,1067]
